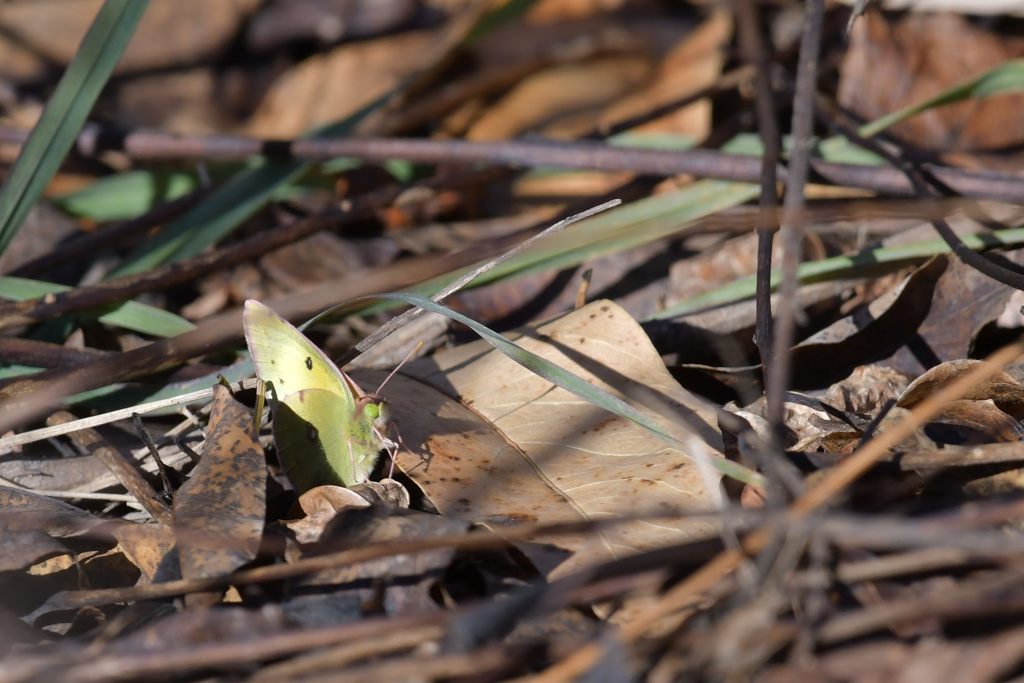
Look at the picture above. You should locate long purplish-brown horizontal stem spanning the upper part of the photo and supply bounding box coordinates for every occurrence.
[0,128,1024,203]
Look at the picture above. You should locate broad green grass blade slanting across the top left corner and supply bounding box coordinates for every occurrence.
[0,0,148,253]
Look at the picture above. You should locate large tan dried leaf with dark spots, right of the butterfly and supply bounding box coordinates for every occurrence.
[364,301,720,575]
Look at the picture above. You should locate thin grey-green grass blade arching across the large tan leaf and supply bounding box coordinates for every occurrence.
[373,293,764,485]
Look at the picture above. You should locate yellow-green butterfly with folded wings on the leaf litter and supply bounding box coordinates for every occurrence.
[242,299,397,493]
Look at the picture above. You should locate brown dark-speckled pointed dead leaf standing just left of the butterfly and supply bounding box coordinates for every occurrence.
[174,385,266,602]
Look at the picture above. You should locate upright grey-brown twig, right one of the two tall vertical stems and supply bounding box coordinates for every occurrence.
[767,0,824,432]
